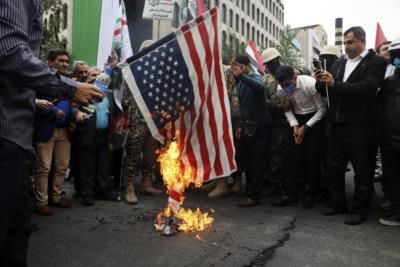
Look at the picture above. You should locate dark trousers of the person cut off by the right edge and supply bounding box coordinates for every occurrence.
[381,151,400,212]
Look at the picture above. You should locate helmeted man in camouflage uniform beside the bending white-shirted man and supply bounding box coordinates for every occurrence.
[261,48,292,198]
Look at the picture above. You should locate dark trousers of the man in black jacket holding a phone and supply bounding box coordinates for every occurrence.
[326,123,375,214]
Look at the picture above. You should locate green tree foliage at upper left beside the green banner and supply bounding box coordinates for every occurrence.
[40,0,67,61]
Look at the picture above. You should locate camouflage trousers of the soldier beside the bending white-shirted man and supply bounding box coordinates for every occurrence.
[266,126,292,184]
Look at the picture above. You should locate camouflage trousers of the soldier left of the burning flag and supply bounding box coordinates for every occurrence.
[122,122,159,184]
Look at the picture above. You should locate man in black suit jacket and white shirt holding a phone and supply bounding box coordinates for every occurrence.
[315,27,385,225]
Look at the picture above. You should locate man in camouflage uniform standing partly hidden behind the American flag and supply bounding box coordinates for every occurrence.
[122,40,162,204]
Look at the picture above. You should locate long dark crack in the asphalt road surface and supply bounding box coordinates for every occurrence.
[244,216,296,267]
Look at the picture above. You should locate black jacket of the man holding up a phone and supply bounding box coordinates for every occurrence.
[316,49,386,128]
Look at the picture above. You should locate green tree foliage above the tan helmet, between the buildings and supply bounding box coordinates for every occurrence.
[272,25,301,66]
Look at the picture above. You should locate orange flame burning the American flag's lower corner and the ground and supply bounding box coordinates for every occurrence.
[156,141,214,232]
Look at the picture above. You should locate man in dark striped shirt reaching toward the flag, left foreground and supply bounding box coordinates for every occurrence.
[0,0,103,266]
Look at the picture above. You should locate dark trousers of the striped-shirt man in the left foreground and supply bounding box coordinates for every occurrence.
[0,138,31,267]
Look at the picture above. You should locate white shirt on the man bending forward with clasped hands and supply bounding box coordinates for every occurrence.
[278,75,326,127]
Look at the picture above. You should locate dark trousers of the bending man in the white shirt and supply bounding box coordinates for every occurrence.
[284,113,323,195]
